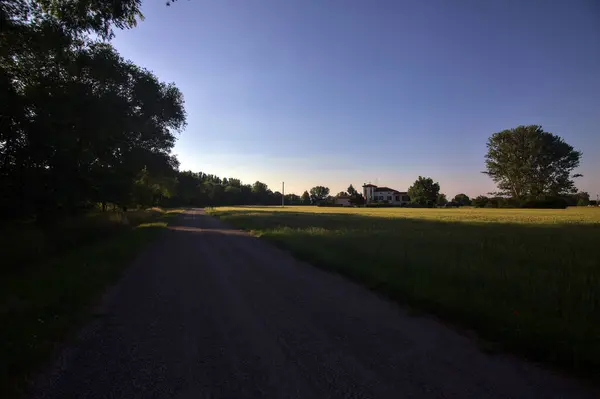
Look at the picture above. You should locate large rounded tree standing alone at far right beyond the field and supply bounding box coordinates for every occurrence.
[483,125,581,200]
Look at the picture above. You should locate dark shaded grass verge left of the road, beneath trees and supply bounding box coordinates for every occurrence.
[0,209,183,398]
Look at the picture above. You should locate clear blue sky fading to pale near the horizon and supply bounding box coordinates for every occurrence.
[113,0,600,197]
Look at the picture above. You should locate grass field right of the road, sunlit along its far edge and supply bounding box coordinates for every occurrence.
[210,207,600,376]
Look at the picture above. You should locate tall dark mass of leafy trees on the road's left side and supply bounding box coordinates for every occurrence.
[0,0,186,222]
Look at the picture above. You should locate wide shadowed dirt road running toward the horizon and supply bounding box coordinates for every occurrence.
[33,210,597,399]
